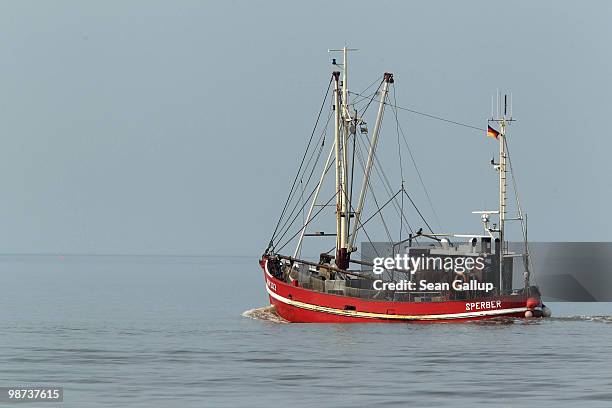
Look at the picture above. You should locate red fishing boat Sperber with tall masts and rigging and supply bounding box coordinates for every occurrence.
[259,47,551,323]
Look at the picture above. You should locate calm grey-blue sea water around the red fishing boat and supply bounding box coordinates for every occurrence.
[0,256,612,407]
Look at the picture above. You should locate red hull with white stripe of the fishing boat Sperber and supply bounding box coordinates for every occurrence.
[261,259,541,323]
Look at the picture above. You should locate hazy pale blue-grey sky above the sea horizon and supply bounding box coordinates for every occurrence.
[0,1,612,255]
